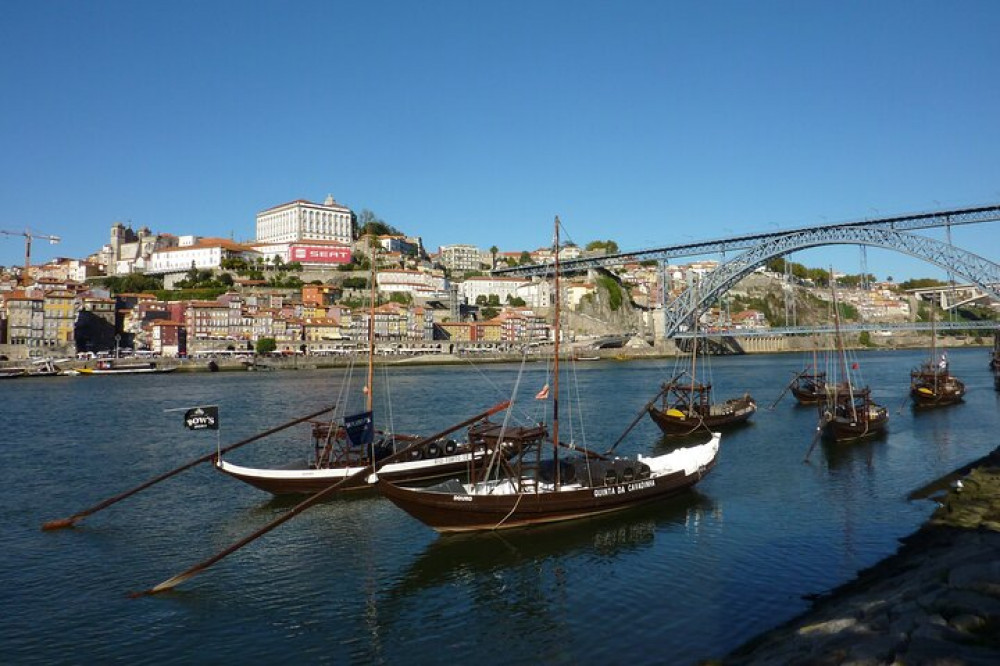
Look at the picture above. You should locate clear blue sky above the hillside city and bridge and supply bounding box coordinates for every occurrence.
[0,0,1000,280]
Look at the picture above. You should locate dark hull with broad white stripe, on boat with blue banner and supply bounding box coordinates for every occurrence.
[215,451,500,495]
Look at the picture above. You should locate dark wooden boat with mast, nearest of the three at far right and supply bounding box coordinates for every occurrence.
[819,276,889,442]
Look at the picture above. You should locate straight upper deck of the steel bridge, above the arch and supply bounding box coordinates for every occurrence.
[493,205,1000,277]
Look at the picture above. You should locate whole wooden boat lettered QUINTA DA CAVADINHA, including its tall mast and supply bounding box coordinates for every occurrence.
[379,217,721,532]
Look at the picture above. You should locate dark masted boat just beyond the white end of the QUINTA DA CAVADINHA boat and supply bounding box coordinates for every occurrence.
[647,300,757,435]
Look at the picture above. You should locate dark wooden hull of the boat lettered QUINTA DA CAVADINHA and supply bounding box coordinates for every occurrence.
[379,434,719,532]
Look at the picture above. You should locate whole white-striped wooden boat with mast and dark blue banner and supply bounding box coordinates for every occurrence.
[215,241,524,495]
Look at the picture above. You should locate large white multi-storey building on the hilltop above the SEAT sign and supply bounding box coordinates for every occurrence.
[257,196,354,244]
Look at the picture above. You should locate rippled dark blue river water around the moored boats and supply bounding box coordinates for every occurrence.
[0,349,1000,664]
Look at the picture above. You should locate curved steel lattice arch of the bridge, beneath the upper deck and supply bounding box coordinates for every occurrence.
[664,226,1000,338]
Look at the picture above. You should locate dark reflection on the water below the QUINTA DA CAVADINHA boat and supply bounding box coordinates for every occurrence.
[389,491,715,598]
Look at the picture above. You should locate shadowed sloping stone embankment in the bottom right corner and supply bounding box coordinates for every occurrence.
[706,448,1000,666]
